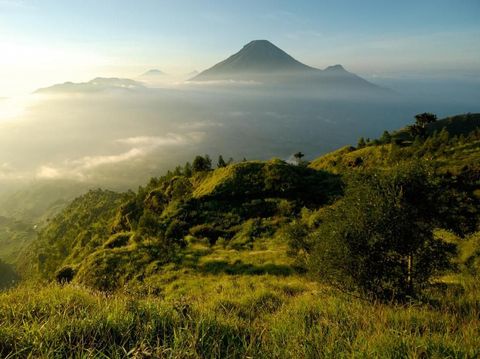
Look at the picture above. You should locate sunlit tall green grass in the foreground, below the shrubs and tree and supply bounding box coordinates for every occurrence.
[0,239,480,358]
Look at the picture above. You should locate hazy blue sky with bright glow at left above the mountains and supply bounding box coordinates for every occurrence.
[0,0,480,98]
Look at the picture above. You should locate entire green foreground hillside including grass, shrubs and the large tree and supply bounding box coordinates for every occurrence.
[0,112,480,358]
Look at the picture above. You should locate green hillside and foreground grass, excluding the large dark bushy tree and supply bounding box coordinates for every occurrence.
[0,116,480,358]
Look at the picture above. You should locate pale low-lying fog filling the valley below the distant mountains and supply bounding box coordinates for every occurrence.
[0,79,480,194]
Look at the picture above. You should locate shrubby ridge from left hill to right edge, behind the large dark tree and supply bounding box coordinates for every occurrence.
[21,112,480,290]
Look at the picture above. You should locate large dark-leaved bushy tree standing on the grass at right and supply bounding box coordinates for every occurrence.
[308,165,454,300]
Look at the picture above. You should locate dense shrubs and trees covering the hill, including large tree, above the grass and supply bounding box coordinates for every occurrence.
[12,113,480,298]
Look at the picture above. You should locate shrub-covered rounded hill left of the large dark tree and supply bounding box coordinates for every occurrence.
[20,160,340,290]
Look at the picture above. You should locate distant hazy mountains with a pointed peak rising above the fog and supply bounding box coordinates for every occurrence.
[35,40,386,97]
